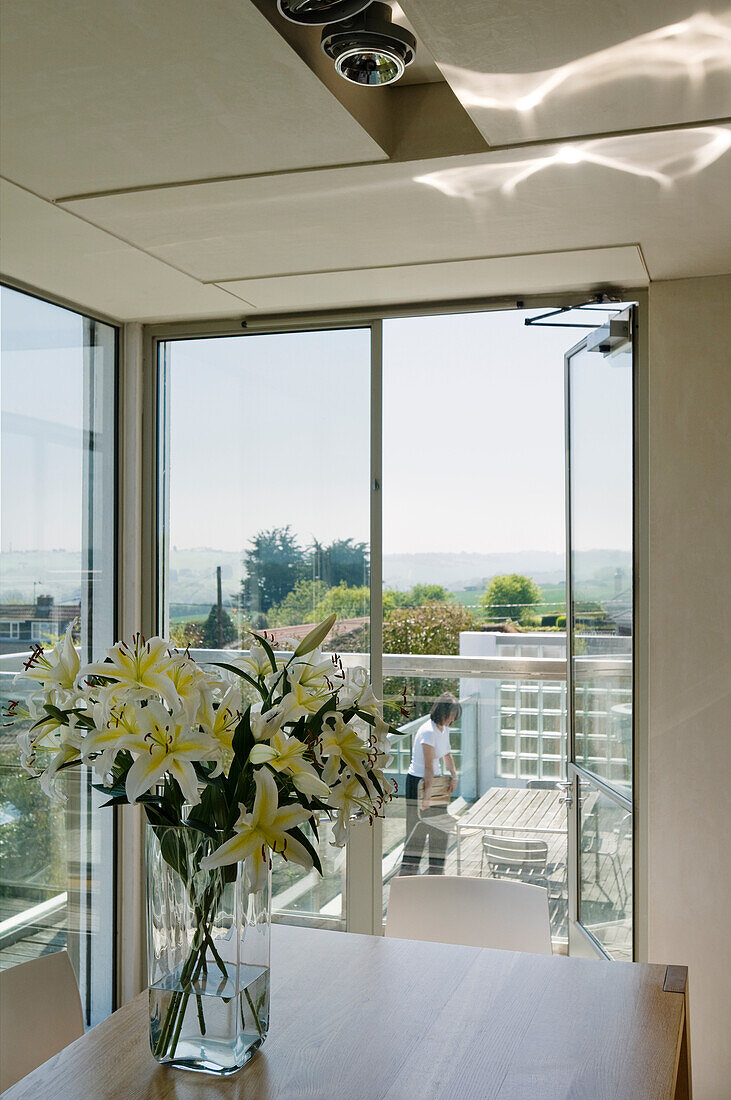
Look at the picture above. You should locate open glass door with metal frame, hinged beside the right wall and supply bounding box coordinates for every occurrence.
[565,307,634,959]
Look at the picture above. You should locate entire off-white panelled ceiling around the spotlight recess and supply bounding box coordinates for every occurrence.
[0,0,731,320]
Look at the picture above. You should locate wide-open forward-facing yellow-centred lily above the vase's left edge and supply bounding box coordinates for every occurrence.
[125,702,219,805]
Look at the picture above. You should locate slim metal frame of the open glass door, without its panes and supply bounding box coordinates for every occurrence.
[564,305,646,961]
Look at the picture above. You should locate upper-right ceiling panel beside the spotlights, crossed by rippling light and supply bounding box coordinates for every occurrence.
[405,0,731,145]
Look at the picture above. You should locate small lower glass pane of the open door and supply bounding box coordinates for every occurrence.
[579,779,632,961]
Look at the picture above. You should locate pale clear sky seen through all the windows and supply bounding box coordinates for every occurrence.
[0,292,629,576]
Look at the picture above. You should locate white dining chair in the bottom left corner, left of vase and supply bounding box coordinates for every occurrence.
[0,952,84,1092]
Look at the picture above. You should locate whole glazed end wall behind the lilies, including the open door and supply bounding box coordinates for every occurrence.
[157,309,633,957]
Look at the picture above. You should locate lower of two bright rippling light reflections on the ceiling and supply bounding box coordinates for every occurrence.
[414,127,731,199]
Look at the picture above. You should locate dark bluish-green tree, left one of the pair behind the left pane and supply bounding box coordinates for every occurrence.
[241,525,308,615]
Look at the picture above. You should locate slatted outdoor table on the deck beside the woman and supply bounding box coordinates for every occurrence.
[455,787,567,875]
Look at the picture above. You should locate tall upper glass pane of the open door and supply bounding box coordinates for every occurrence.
[569,336,632,791]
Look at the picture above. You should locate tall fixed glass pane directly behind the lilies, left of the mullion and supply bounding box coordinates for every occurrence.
[160,329,370,927]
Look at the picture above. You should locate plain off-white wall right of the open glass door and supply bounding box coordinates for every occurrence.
[647,276,731,1100]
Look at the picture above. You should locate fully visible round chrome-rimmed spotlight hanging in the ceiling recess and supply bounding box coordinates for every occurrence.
[322,2,417,87]
